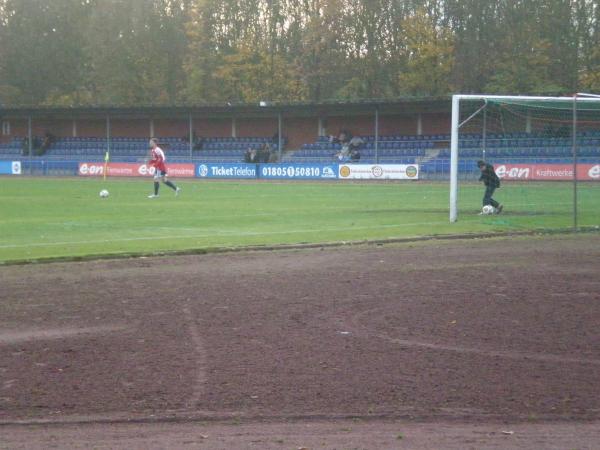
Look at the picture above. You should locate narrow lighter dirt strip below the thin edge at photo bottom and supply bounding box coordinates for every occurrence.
[0,420,600,450]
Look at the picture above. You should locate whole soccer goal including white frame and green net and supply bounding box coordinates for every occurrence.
[450,94,600,228]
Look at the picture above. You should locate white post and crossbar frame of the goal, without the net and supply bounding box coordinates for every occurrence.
[450,93,600,222]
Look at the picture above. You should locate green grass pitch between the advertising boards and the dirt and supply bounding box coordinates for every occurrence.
[0,177,600,263]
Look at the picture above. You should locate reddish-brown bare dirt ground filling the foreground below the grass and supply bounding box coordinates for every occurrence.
[0,234,600,449]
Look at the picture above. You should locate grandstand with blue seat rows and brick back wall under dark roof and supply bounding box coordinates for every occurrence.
[0,99,600,178]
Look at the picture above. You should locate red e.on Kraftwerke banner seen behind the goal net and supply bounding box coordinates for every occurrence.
[494,164,600,181]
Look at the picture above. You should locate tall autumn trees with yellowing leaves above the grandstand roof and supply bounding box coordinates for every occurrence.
[0,0,600,106]
